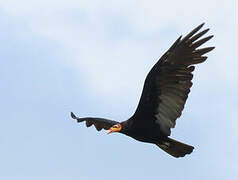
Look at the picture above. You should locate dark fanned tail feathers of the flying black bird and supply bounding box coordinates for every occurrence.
[157,138,194,158]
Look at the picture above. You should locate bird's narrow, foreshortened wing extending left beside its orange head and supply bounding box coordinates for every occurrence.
[71,112,118,131]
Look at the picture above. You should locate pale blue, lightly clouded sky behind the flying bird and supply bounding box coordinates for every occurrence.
[0,0,238,180]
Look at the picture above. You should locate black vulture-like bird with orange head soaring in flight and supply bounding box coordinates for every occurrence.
[71,23,215,157]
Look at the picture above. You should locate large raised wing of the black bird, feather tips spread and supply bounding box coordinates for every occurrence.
[134,24,214,136]
